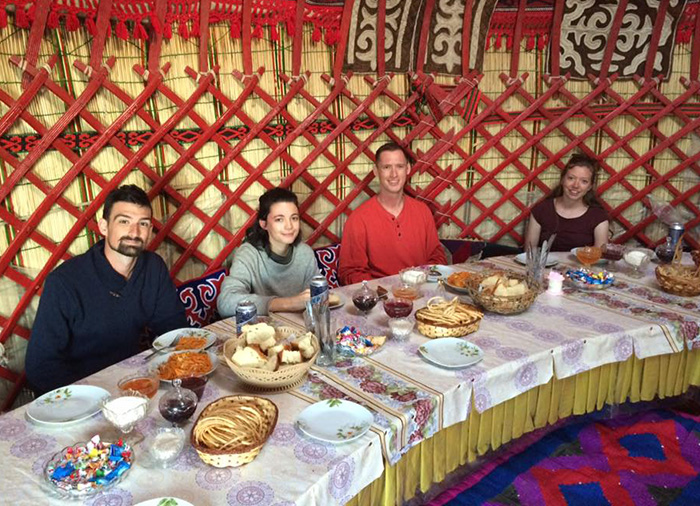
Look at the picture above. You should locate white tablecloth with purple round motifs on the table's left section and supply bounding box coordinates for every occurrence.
[0,316,384,506]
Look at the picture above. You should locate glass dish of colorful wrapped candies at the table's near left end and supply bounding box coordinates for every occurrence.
[44,436,134,498]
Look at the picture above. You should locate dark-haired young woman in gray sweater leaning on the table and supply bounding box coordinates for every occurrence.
[217,188,319,317]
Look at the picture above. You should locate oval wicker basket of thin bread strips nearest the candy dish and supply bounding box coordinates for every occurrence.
[190,395,279,467]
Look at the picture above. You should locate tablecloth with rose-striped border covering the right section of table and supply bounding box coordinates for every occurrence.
[276,253,700,464]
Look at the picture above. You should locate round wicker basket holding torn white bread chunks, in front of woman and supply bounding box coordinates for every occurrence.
[224,327,320,392]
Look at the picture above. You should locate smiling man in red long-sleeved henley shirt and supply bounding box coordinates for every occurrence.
[338,142,447,285]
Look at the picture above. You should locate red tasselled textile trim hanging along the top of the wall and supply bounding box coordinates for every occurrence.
[0,0,700,49]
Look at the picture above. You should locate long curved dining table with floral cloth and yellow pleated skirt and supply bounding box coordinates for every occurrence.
[0,253,700,506]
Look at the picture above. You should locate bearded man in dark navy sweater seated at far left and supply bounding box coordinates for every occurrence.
[25,185,188,394]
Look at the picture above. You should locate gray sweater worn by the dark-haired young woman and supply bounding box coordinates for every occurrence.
[216,243,319,317]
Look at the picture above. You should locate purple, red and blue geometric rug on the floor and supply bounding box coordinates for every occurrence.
[429,410,700,506]
